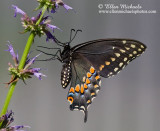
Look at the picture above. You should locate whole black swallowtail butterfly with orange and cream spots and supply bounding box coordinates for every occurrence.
[39,29,146,122]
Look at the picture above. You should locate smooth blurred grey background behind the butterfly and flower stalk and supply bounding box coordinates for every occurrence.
[0,0,160,131]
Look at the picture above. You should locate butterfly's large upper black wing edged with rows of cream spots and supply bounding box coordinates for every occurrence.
[74,39,146,77]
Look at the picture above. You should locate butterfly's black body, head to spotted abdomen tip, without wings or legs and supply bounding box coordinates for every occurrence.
[61,45,72,88]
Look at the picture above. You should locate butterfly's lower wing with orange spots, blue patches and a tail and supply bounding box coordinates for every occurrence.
[67,54,100,122]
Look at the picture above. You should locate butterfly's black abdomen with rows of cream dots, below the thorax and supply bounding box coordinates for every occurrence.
[61,63,71,88]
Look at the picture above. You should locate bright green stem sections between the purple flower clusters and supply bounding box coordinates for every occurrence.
[0,6,47,127]
